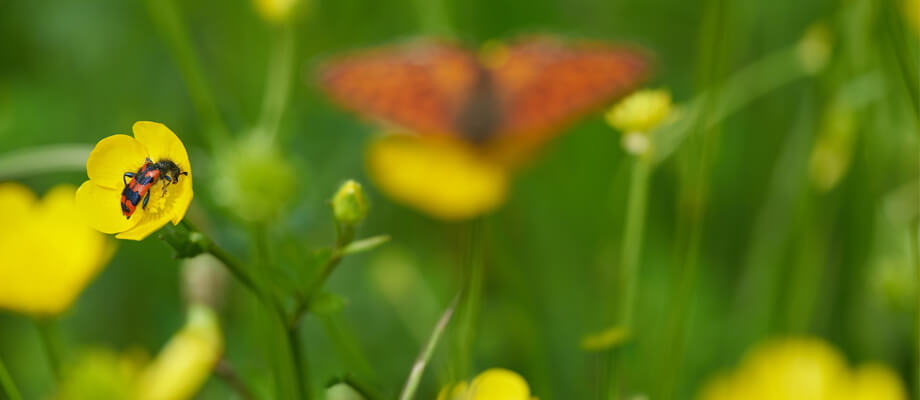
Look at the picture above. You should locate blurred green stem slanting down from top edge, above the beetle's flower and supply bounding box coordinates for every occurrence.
[147,0,229,146]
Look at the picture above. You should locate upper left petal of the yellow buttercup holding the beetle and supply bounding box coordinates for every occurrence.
[86,135,148,190]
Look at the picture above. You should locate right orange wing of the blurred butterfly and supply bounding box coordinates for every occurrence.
[492,37,649,142]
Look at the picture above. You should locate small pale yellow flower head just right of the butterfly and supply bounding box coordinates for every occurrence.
[604,89,671,134]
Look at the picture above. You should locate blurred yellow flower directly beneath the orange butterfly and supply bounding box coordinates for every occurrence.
[367,135,510,220]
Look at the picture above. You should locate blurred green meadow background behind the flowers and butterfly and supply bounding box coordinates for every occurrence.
[0,0,920,400]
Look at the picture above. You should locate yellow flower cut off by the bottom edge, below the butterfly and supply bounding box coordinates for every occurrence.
[437,368,532,400]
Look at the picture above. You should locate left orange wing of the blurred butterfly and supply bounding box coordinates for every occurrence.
[319,41,481,135]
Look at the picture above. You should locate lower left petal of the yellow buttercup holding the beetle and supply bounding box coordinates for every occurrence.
[76,180,142,233]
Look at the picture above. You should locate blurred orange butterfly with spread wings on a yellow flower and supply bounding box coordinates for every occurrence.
[319,36,649,161]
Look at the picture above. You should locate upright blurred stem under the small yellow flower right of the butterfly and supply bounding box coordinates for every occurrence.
[602,155,652,399]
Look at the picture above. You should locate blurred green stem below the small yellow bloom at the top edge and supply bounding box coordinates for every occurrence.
[258,23,295,142]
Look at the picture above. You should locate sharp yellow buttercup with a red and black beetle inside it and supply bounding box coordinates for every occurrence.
[77,121,193,240]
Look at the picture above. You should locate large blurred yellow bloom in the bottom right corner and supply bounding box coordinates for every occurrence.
[698,338,906,400]
